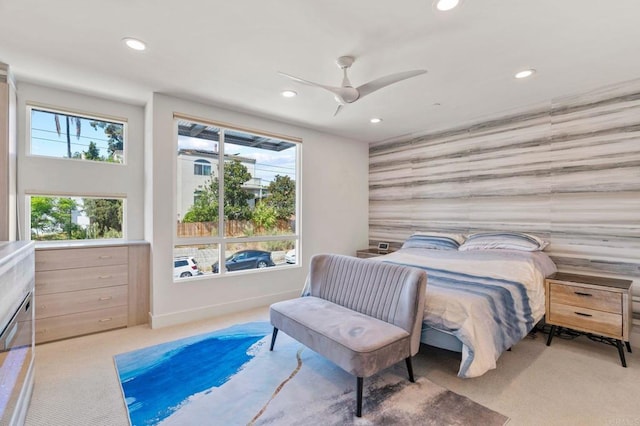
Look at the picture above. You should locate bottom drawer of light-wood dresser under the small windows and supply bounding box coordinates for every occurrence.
[35,306,127,343]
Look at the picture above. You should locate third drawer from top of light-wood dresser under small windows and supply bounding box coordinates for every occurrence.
[35,285,129,320]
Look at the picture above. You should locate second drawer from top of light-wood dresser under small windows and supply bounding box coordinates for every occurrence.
[36,265,129,295]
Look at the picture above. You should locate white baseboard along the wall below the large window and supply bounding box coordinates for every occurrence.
[149,290,300,328]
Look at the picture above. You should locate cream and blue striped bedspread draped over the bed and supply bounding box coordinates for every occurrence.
[375,248,556,378]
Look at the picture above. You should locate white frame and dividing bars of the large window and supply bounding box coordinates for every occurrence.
[171,113,302,282]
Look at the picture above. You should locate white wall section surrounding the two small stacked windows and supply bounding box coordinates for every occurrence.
[18,83,144,240]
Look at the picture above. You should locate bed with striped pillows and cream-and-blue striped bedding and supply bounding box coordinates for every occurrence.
[302,232,556,378]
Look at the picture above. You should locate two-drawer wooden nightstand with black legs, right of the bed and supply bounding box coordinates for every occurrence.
[545,272,631,367]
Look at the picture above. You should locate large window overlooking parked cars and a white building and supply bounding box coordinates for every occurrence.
[174,118,300,278]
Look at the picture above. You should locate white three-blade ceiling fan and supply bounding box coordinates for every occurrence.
[278,56,427,117]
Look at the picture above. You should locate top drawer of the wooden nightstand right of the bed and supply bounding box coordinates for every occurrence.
[549,283,622,314]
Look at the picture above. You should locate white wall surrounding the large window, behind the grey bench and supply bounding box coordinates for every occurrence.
[145,94,369,327]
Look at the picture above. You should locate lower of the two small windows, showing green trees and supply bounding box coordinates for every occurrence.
[28,195,124,241]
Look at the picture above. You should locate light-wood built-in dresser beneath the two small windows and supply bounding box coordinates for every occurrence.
[35,242,149,343]
